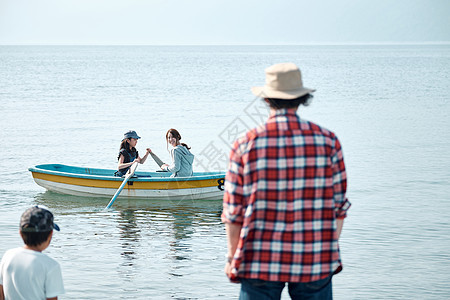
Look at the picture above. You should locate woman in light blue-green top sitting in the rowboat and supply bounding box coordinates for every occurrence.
[161,128,194,177]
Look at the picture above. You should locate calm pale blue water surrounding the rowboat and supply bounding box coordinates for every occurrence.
[0,45,450,299]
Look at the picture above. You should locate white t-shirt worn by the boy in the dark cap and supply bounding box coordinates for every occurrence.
[0,248,64,300]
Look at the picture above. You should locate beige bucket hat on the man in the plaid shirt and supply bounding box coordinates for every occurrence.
[251,63,316,100]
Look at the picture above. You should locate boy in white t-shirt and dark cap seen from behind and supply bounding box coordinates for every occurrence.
[0,206,64,300]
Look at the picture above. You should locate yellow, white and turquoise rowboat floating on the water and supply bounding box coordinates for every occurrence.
[28,164,225,200]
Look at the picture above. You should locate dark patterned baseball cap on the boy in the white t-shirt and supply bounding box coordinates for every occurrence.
[20,205,59,232]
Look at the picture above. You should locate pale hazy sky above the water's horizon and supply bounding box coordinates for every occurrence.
[0,0,450,45]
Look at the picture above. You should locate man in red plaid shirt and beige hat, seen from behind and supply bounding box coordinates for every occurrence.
[222,63,350,300]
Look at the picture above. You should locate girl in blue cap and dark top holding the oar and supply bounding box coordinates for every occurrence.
[114,130,151,177]
